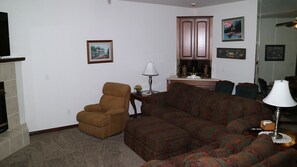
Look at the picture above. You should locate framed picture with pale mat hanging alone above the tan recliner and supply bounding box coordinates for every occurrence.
[87,40,113,64]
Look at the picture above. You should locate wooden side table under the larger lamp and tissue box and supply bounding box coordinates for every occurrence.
[243,128,297,151]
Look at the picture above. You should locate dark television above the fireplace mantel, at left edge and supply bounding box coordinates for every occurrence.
[0,12,10,57]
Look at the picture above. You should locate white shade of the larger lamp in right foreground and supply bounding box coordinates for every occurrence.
[263,80,297,107]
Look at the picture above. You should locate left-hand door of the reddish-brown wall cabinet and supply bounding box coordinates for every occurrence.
[177,18,195,59]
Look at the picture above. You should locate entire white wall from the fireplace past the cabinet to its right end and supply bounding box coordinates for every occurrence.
[0,0,257,132]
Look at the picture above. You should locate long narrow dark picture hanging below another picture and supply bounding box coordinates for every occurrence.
[217,48,246,59]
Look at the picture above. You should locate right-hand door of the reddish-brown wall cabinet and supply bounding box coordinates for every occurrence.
[193,18,210,59]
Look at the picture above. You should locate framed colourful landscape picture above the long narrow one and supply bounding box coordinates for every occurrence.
[222,17,244,41]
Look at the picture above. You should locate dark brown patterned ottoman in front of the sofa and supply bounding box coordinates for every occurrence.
[124,117,191,161]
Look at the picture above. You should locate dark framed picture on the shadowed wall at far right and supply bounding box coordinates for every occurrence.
[265,45,285,61]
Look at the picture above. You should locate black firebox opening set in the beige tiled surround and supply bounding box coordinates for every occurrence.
[0,82,8,133]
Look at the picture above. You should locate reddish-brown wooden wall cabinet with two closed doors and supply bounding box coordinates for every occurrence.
[177,16,212,60]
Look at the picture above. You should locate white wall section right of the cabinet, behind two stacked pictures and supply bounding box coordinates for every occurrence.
[197,0,258,84]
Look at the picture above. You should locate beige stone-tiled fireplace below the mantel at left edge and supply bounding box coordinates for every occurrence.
[0,59,30,161]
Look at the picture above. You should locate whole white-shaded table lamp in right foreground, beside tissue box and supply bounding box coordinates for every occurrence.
[263,80,297,139]
